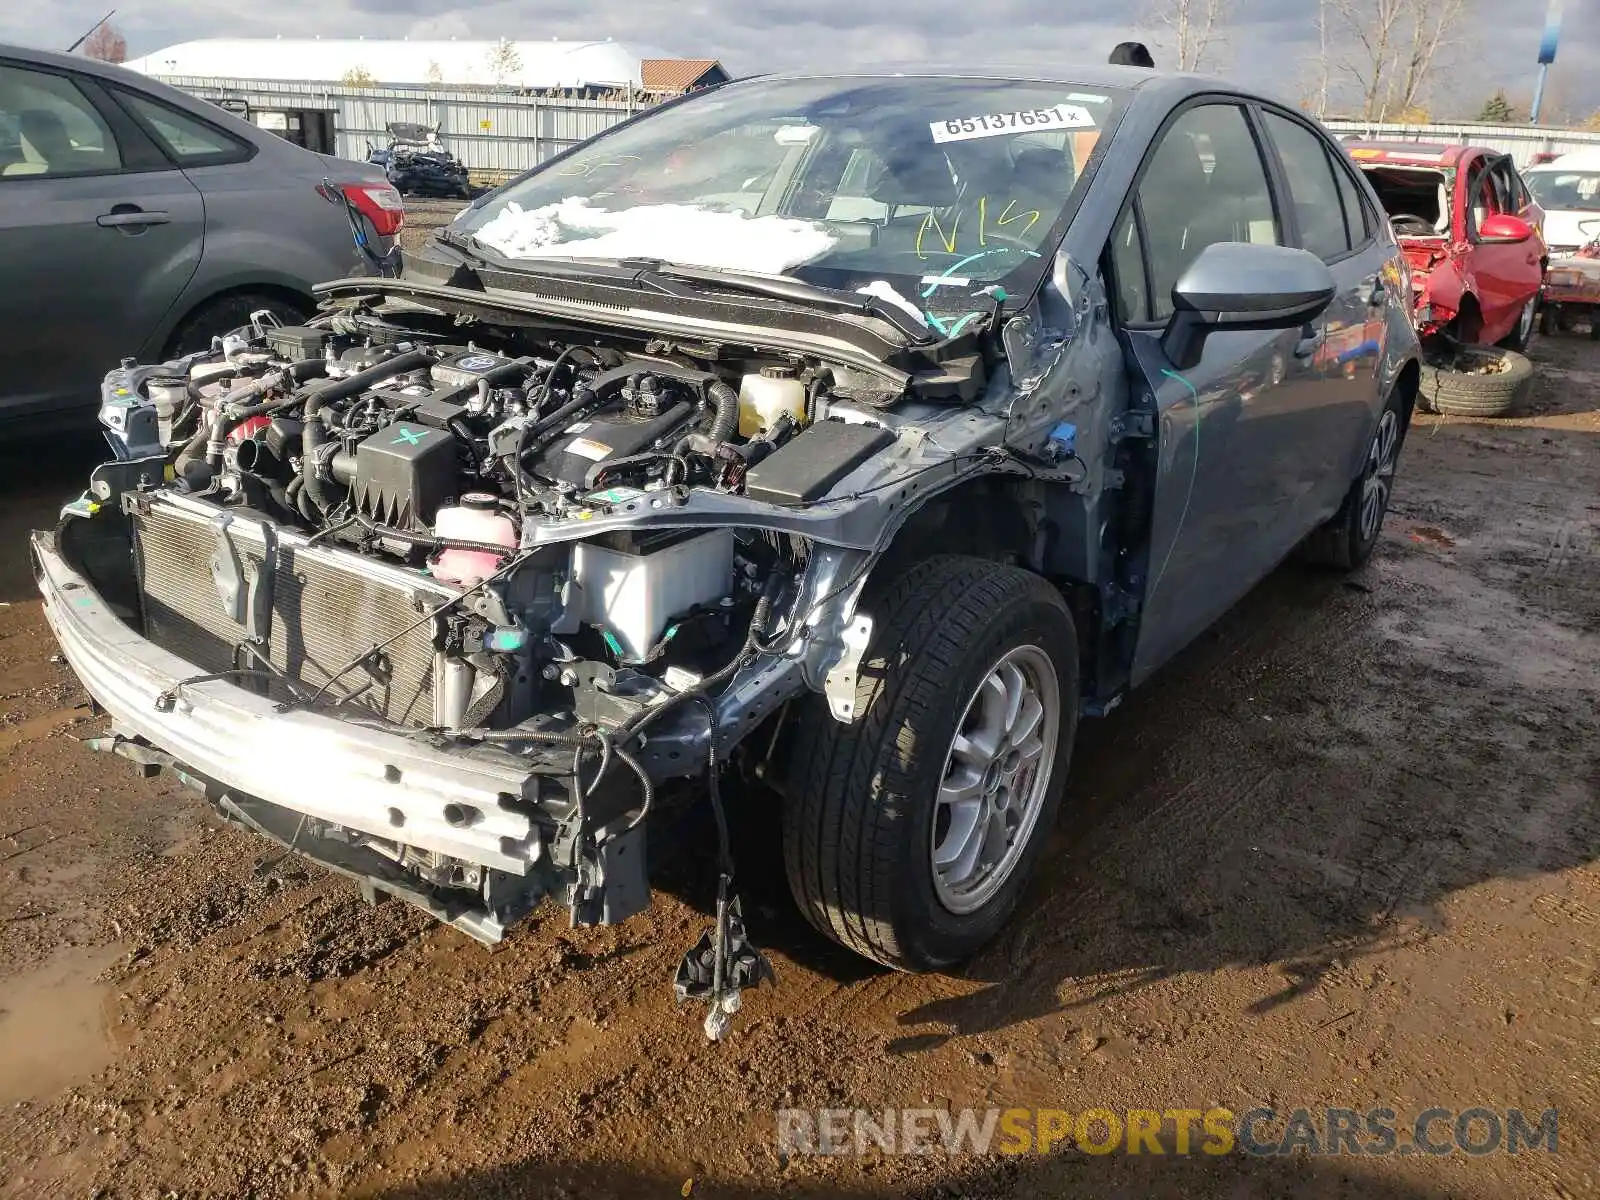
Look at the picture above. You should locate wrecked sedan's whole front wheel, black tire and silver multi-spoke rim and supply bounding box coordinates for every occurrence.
[782,555,1078,971]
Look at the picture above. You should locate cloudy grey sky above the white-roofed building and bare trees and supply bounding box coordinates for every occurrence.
[0,0,1600,117]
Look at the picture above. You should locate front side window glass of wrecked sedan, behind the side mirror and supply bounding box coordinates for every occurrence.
[1138,104,1283,322]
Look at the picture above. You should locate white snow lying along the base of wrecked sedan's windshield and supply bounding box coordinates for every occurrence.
[475,197,838,278]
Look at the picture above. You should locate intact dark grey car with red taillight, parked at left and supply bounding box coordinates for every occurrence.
[0,45,405,438]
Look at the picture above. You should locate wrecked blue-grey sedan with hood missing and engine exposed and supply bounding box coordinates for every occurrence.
[32,67,1418,1037]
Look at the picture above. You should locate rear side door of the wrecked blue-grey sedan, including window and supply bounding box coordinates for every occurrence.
[1262,109,1395,512]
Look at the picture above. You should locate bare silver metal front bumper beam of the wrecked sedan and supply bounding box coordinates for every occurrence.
[32,521,648,941]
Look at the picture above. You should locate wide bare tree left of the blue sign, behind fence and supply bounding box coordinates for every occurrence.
[1323,0,1472,120]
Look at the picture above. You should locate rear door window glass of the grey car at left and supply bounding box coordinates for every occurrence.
[0,66,122,179]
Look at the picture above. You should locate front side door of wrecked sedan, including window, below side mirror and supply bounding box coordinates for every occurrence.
[1107,101,1322,682]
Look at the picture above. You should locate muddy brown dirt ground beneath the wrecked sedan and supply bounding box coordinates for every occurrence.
[0,286,1600,1200]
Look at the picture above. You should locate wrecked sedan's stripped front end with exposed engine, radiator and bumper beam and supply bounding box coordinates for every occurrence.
[34,291,1070,939]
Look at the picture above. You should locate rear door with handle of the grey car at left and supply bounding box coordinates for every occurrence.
[0,59,205,426]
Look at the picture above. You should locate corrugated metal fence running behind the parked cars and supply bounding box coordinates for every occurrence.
[160,75,1600,174]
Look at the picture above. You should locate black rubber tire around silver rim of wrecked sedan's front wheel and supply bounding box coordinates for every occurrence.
[782,555,1078,971]
